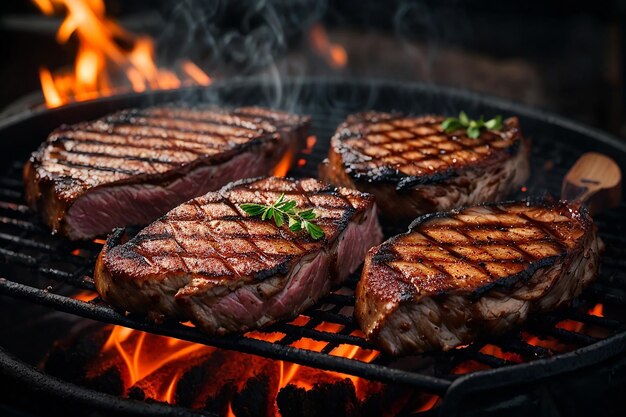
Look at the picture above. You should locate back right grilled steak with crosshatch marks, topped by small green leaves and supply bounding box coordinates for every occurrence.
[320,112,529,222]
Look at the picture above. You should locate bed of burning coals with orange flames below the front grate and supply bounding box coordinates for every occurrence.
[45,320,437,417]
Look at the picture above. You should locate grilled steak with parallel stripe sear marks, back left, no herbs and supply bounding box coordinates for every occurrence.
[24,107,309,239]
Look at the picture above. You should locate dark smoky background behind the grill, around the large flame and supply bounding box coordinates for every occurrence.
[0,0,626,135]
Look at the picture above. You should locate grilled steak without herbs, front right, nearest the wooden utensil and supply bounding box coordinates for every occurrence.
[355,202,603,355]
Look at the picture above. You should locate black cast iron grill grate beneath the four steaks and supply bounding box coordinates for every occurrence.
[0,81,626,395]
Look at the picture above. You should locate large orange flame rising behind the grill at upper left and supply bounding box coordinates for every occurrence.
[33,0,211,107]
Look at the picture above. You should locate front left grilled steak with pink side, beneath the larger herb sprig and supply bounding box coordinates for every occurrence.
[95,177,382,334]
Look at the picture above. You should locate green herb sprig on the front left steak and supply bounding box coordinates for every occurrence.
[239,193,324,240]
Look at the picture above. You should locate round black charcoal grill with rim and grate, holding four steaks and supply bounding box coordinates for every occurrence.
[0,79,626,415]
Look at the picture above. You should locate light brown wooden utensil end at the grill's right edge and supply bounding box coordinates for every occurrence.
[561,152,622,215]
